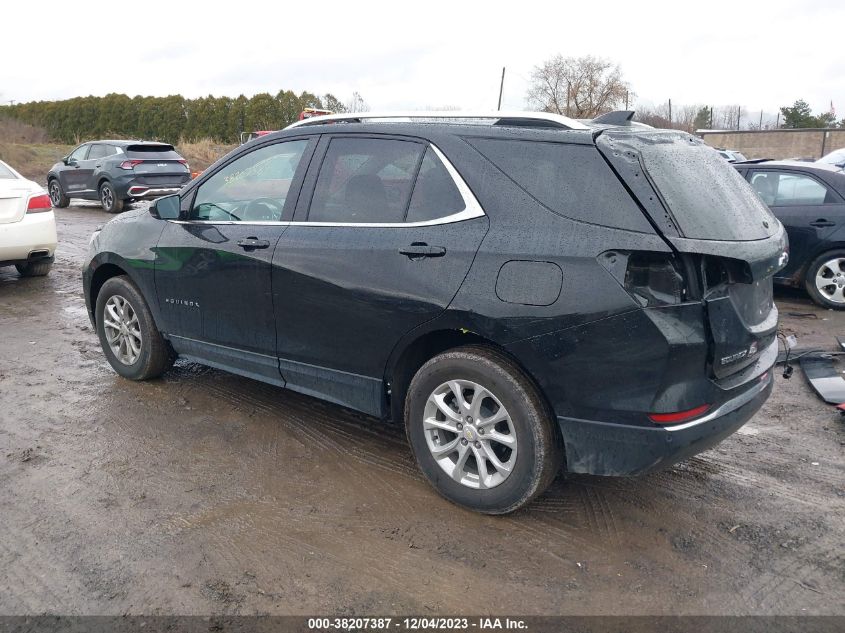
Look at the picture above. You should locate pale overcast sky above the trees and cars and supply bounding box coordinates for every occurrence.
[0,0,845,118]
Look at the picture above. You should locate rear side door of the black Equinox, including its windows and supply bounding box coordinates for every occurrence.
[273,135,488,415]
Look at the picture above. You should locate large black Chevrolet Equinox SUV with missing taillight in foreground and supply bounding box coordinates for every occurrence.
[84,112,786,513]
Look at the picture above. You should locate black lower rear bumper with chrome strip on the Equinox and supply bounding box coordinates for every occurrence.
[557,371,774,476]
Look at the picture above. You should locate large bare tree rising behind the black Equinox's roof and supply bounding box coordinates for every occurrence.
[526,55,632,118]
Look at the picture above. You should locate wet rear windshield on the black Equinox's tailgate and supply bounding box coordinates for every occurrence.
[630,132,778,240]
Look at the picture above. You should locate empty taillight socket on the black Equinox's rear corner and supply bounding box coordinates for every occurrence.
[625,253,687,307]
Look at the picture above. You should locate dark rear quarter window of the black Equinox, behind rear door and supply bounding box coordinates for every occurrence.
[465,138,653,233]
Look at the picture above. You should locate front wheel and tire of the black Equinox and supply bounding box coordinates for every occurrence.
[95,276,176,380]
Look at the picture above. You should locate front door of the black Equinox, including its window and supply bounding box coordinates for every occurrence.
[155,137,316,384]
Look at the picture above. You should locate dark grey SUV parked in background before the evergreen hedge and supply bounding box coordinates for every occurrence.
[47,141,191,213]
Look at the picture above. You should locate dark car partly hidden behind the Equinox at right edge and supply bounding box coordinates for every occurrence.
[734,161,845,310]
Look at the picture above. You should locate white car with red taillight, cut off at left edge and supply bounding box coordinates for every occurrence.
[0,161,57,277]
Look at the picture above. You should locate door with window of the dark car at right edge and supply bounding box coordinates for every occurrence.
[747,169,845,279]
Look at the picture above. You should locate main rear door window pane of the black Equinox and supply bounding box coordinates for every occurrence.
[308,138,425,224]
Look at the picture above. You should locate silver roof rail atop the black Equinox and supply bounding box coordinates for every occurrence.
[285,110,589,130]
